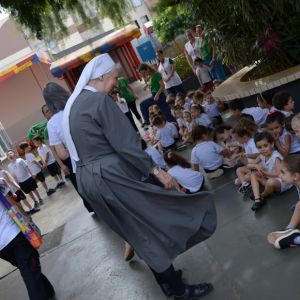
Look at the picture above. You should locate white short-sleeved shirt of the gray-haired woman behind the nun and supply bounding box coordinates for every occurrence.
[47,111,67,147]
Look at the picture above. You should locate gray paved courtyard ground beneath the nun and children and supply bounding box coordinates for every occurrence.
[0,83,300,300]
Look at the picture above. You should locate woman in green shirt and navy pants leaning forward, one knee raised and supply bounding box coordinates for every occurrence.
[139,63,176,127]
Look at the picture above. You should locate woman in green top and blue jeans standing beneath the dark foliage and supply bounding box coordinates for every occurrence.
[196,25,227,81]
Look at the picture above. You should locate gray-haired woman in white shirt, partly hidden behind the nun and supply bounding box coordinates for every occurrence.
[42,82,94,212]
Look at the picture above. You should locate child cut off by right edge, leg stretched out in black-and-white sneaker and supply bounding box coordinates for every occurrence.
[268,154,300,249]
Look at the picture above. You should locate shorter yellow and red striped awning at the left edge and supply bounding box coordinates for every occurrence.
[0,52,52,82]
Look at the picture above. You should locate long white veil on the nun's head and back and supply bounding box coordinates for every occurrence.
[63,53,115,161]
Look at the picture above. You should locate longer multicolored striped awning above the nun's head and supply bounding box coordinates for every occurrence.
[50,25,142,77]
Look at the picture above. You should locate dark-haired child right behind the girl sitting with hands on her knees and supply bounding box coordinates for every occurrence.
[266,111,300,157]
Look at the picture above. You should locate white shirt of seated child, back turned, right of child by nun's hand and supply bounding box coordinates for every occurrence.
[191,141,223,170]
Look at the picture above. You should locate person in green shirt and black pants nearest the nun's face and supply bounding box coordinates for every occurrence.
[118,77,143,124]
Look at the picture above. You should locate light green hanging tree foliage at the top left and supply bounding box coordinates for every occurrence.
[0,0,132,40]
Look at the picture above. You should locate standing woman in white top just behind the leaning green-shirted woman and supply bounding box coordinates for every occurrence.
[156,50,186,94]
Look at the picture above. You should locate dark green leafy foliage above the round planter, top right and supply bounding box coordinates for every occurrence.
[154,0,300,77]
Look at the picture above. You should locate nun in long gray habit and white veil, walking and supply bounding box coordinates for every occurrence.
[63,54,217,300]
